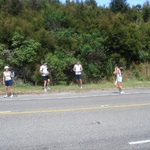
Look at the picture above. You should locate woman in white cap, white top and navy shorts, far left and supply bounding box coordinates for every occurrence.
[3,66,13,98]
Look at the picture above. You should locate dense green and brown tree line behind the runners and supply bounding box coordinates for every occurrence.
[0,0,150,84]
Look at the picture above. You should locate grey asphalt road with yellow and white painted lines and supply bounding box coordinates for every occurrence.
[0,88,150,150]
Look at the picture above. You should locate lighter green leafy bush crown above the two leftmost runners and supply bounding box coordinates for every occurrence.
[8,33,40,67]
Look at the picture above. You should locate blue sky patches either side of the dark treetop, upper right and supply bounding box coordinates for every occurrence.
[96,0,150,7]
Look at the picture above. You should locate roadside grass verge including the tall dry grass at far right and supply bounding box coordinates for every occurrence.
[0,63,150,94]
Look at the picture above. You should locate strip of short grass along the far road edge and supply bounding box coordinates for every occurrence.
[0,80,150,95]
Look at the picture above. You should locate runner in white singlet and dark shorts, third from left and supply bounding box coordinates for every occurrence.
[73,61,83,88]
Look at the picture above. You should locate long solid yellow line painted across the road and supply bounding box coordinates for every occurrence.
[0,103,150,115]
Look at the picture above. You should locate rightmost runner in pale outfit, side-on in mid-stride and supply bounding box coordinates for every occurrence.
[114,65,124,94]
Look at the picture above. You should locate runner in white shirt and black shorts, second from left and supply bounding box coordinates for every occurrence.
[40,61,50,92]
